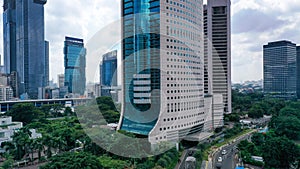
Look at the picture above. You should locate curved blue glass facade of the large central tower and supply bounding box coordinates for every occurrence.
[121,0,160,135]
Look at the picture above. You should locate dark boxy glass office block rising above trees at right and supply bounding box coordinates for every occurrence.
[263,41,297,99]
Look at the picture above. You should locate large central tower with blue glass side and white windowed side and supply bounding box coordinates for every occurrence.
[119,0,206,144]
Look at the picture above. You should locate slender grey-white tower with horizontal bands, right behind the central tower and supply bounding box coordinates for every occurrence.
[204,0,231,113]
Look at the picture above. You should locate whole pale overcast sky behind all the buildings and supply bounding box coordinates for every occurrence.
[0,0,300,82]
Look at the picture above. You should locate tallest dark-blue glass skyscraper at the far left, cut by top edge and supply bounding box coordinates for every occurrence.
[3,0,47,98]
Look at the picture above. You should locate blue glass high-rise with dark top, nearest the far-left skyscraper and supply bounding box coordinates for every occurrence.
[64,37,86,95]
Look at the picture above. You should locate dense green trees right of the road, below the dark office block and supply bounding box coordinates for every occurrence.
[232,91,300,169]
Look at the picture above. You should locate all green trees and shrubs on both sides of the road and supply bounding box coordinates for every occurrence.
[1,91,300,169]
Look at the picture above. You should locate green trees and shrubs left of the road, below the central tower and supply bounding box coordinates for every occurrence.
[1,97,181,169]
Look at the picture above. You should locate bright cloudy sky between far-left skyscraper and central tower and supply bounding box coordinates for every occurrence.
[45,0,120,81]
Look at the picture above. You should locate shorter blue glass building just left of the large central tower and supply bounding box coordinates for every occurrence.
[100,50,118,96]
